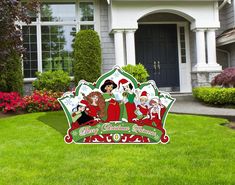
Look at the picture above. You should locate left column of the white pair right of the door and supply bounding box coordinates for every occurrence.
[194,29,206,71]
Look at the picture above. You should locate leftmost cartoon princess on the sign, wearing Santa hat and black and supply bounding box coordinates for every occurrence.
[72,100,94,125]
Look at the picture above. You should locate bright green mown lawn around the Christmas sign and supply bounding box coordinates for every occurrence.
[0,112,235,185]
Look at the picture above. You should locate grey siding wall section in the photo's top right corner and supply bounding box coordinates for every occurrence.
[217,0,235,35]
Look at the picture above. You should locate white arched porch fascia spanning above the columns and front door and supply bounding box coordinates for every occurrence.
[110,1,220,29]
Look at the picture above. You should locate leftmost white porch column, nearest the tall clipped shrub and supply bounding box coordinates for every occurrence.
[114,30,125,67]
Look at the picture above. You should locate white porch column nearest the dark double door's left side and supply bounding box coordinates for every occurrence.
[125,30,136,65]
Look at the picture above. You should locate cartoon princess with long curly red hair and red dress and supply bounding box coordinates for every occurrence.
[84,91,105,119]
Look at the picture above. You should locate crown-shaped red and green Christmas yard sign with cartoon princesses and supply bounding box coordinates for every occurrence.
[58,66,175,144]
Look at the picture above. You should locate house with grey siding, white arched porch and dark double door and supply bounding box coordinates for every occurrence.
[22,0,229,93]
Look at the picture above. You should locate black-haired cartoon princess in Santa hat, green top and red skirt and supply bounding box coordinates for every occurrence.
[118,79,136,122]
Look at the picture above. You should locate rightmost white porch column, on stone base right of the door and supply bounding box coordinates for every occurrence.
[206,29,221,70]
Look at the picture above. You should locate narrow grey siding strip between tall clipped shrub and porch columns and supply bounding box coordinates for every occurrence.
[100,0,115,73]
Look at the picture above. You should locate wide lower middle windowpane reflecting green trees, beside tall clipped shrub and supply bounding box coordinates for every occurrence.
[41,26,76,75]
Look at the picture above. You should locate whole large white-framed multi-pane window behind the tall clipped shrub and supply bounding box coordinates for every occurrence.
[22,1,95,78]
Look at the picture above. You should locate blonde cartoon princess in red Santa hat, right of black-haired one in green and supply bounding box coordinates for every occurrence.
[136,91,149,119]
